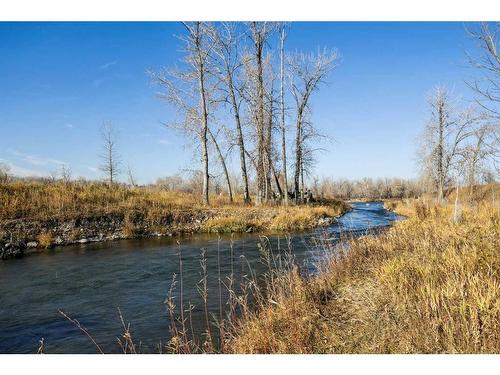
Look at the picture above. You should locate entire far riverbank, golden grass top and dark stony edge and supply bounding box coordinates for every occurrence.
[0,182,349,259]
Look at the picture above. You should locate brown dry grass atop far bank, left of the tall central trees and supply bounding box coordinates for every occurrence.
[0,181,232,220]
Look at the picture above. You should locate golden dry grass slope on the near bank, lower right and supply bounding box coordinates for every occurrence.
[226,194,500,353]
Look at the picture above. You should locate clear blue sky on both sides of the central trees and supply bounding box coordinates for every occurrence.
[0,23,473,183]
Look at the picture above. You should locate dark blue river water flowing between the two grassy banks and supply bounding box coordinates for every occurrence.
[0,202,398,353]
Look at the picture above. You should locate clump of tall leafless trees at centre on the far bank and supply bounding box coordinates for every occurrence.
[151,22,338,204]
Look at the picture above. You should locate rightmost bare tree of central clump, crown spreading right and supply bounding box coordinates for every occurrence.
[288,49,338,201]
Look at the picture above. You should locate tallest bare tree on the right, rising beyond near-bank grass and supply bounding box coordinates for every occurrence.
[419,87,477,202]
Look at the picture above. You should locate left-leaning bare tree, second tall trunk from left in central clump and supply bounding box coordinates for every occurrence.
[210,22,251,203]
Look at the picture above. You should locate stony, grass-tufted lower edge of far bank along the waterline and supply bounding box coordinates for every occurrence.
[0,201,349,259]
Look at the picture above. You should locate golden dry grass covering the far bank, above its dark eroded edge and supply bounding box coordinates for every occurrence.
[0,182,348,244]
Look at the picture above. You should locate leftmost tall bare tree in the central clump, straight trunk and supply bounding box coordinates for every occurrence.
[152,22,212,205]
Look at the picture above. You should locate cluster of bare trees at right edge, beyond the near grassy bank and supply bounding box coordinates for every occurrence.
[419,23,500,201]
